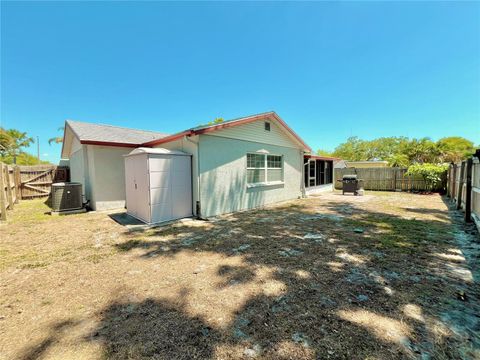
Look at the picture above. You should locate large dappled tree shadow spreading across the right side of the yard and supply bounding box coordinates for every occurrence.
[87,201,480,359]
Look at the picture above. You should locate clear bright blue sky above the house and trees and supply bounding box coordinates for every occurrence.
[0,1,480,161]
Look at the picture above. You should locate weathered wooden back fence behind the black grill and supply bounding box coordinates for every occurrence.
[334,167,447,191]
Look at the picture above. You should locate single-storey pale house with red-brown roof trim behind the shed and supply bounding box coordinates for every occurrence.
[62,112,333,217]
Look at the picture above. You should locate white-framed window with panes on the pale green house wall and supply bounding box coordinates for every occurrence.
[247,154,283,184]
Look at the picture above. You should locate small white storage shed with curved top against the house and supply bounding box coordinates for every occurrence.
[125,148,192,224]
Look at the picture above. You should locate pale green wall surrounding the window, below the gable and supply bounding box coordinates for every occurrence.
[198,134,303,217]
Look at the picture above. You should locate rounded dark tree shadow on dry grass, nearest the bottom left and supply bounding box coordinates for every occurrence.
[87,299,219,359]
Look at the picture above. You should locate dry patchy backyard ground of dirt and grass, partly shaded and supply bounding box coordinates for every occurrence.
[0,193,480,359]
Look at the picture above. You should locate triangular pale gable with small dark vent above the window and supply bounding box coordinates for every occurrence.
[210,119,298,149]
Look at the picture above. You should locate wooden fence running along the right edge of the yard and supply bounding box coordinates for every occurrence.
[447,150,480,231]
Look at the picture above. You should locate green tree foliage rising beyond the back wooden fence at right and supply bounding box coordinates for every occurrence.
[331,136,475,167]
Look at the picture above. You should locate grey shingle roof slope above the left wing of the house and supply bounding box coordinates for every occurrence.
[66,120,168,145]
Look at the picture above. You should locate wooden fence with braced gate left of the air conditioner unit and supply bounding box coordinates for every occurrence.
[0,162,70,220]
